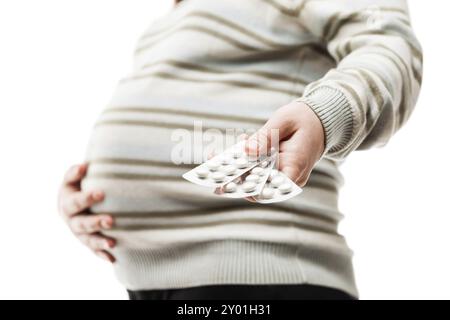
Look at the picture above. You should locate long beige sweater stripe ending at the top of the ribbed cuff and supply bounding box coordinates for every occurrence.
[121,71,302,96]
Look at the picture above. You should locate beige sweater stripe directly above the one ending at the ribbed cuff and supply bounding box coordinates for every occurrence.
[133,60,307,84]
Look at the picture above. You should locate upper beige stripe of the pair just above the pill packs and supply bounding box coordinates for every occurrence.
[103,106,267,125]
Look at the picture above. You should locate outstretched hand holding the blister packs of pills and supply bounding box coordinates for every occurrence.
[246,101,325,187]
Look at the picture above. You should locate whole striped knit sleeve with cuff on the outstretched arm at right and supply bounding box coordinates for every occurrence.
[298,0,422,159]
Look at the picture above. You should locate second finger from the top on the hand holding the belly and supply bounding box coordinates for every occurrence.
[61,191,105,217]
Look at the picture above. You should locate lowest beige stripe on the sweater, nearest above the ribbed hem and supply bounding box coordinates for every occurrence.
[113,218,336,235]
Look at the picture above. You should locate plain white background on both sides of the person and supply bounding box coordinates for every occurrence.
[0,0,450,299]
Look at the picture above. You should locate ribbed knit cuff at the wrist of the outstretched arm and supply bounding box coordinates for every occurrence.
[296,86,353,155]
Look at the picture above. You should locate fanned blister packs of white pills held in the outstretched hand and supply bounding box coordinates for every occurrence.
[183,141,302,203]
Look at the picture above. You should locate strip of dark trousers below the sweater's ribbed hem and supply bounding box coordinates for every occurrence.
[128,285,355,300]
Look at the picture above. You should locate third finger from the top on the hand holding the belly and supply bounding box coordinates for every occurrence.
[68,214,114,234]
